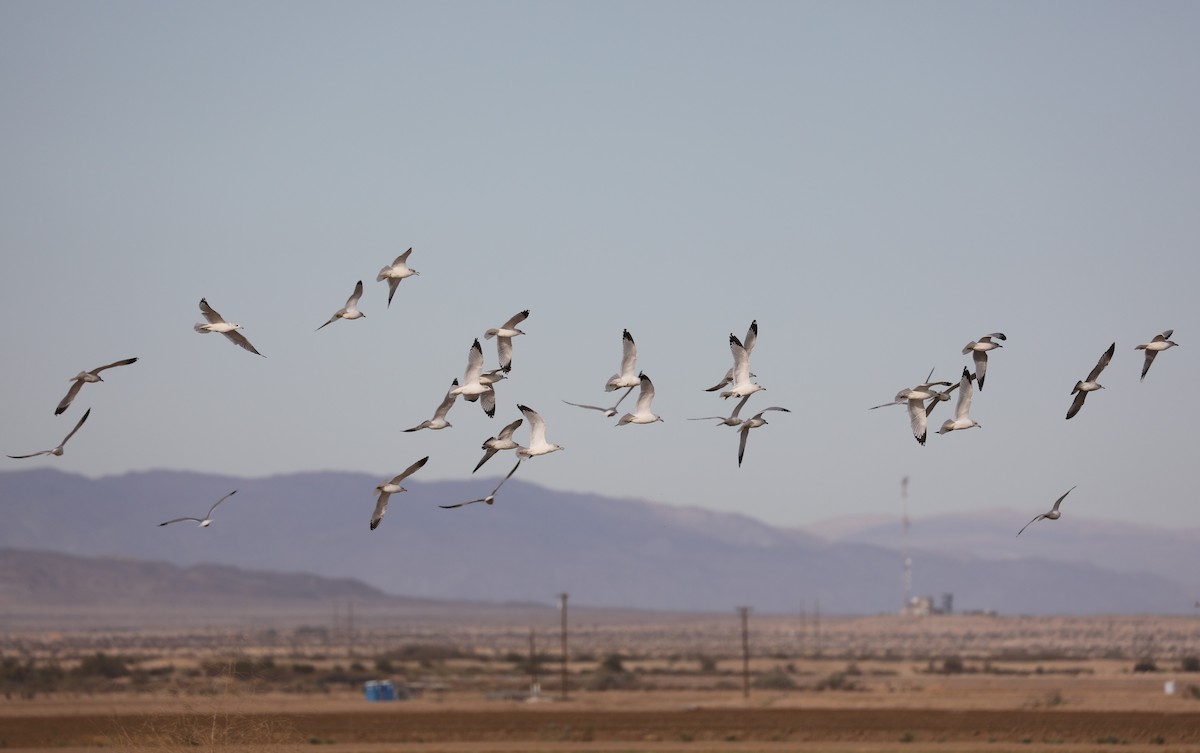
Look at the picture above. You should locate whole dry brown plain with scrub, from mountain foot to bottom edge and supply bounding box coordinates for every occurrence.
[0,607,1200,753]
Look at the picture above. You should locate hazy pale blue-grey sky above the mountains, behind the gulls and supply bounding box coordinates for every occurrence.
[0,1,1200,531]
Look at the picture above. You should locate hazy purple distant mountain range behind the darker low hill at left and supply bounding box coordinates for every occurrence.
[0,469,1200,614]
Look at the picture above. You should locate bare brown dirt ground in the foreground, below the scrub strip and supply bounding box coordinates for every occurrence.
[7,677,1200,753]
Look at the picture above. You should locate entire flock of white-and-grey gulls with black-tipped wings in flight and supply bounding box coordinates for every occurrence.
[8,248,1178,536]
